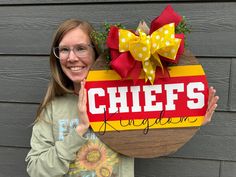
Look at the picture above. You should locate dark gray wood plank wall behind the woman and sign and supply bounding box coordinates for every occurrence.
[0,0,236,177]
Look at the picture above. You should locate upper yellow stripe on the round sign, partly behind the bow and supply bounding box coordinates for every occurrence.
[87,65,205,81]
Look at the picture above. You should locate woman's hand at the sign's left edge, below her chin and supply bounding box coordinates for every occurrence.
[76,80,89,136]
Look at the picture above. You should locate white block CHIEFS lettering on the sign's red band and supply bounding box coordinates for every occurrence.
[88,82,205,114]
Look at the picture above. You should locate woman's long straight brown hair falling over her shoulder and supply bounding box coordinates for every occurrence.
[35,19,99,122]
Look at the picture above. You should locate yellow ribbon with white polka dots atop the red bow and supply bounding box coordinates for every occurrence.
[119,23,181,84]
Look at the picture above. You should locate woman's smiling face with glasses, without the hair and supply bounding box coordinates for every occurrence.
[59,27,95,84]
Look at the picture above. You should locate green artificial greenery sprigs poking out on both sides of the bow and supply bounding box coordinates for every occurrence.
[91,16,191,64]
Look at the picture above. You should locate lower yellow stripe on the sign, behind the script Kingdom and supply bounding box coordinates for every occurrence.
[90,116,204,132]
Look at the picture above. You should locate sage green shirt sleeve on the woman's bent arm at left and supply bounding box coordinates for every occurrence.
[25,104,87,177]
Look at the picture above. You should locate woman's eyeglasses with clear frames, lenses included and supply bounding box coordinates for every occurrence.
[53,44,93,60]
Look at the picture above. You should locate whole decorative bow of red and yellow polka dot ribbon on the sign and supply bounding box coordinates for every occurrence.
[107,6,184,84]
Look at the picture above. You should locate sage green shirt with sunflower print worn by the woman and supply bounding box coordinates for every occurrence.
[26,94,134,177]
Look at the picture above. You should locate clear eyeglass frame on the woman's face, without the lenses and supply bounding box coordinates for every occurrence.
[53,43,94,60]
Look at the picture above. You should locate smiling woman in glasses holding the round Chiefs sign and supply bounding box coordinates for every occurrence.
[26,19,218,177]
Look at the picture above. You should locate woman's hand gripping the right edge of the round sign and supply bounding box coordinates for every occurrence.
[202,87,219,125]
